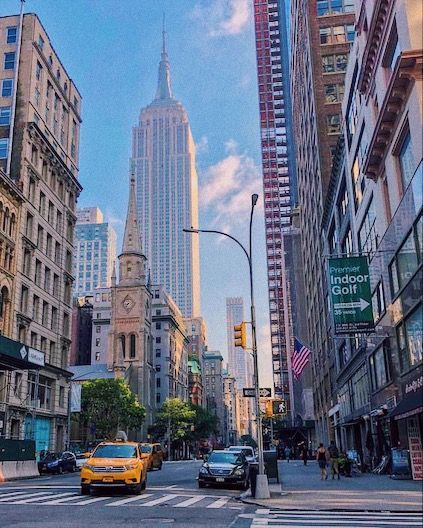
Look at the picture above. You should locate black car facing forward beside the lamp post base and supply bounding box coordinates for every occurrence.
[198,451,249,489]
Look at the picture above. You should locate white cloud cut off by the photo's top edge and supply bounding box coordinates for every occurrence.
[192,0,251,37]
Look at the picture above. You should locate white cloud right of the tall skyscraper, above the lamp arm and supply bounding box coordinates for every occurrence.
[200,140,262,230]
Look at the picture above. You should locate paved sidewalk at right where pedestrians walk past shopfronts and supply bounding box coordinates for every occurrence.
[241,460,423,511]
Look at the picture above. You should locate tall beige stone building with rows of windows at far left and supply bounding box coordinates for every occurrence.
[0,14,82,451]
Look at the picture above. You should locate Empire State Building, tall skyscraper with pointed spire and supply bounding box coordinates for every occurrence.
[131,32,200,317]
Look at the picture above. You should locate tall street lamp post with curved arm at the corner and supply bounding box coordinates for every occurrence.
[183,194,270,499]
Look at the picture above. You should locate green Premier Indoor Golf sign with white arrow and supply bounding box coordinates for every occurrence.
[329,257,374,334]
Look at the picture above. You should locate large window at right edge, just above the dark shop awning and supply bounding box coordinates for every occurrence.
[397,304,423,372]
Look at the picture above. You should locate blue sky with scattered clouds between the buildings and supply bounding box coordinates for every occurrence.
[0,0,271,385]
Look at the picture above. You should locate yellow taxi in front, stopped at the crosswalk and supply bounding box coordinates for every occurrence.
[81,440,147,495]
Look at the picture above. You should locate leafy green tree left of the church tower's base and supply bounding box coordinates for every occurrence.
[81,379,145,439]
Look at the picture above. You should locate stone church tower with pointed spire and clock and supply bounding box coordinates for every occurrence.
[108,175,155,440]
